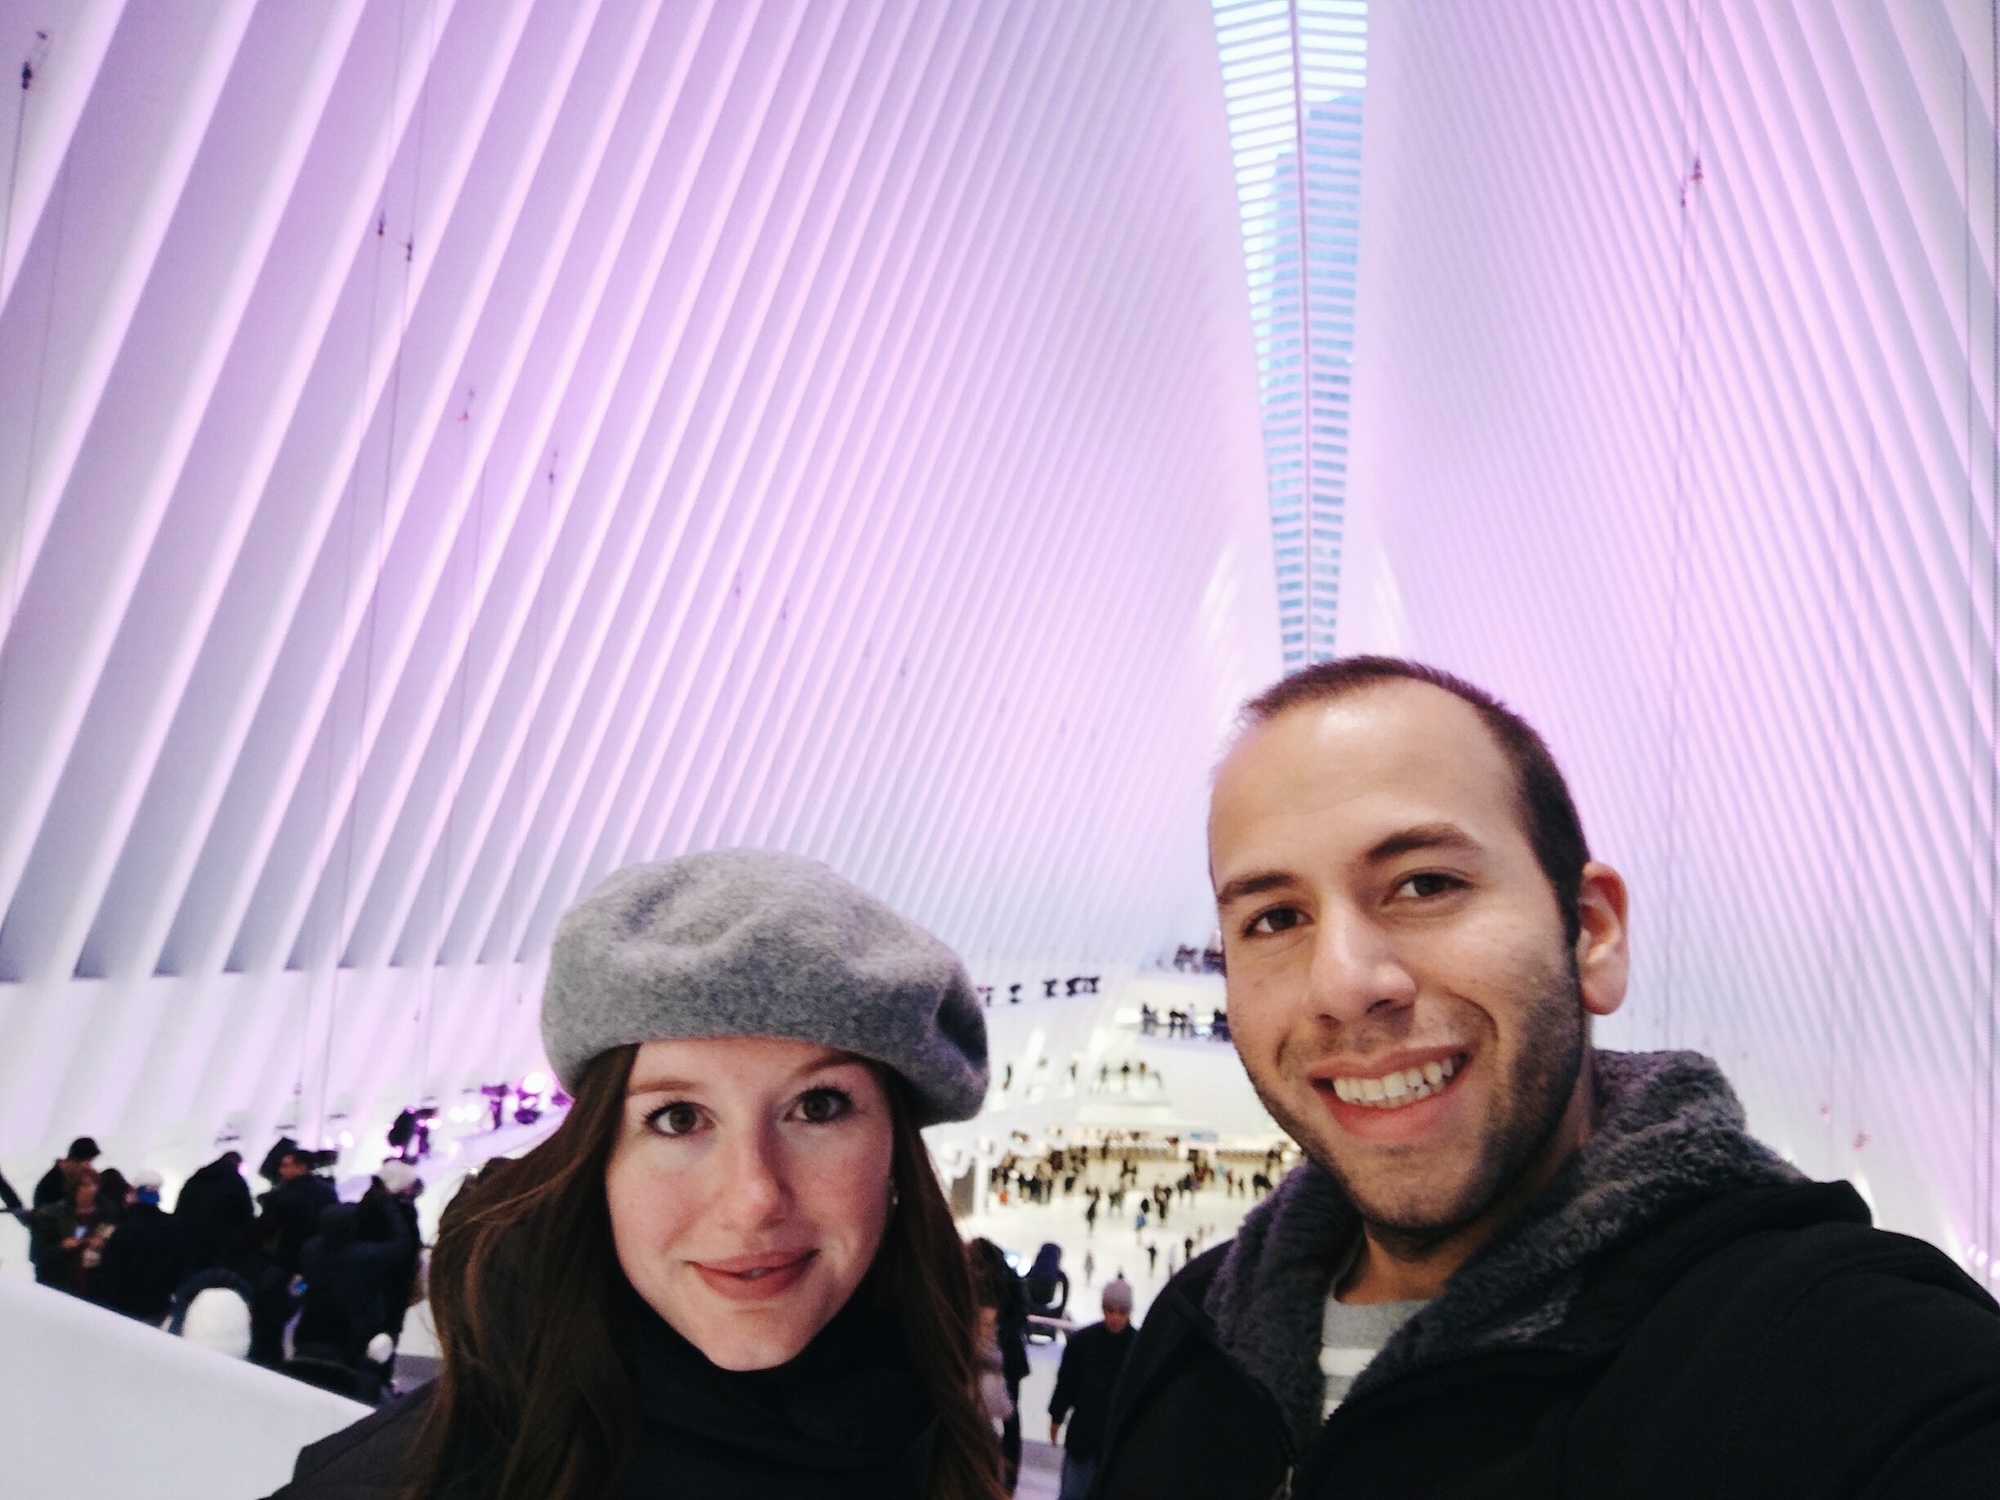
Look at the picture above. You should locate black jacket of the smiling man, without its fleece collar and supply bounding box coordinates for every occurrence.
[1092,1182,2000,1500]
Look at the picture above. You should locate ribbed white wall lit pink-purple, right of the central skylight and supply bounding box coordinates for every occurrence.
[1342,0,2000,1268]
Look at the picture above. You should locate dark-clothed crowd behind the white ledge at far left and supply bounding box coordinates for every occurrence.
[0,1136,424,1400]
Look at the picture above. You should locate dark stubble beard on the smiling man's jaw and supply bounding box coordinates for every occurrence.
[1244,954,1590,1260]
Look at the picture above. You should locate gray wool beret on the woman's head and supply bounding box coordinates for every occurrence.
[542,848,986,1124]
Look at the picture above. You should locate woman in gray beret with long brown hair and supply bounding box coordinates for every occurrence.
[280,850,1000,1500]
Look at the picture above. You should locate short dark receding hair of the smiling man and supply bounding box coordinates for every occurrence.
[1242,656,1590,948]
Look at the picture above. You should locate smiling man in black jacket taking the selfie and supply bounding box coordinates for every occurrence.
[1094,658,2000,1500]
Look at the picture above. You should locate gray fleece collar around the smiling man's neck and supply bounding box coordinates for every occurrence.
[1204,1052,1806,1444]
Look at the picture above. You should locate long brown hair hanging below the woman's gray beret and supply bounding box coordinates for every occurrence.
[404,1046,1004,1500]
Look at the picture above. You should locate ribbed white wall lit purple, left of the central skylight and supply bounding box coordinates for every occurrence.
[0,0,1278,1164]
